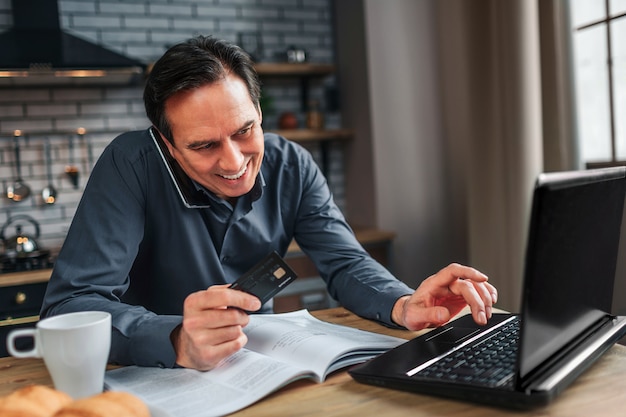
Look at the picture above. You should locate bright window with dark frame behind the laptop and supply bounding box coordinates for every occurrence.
[570,0,626,167]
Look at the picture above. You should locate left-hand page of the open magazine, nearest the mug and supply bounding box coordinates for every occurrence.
[105,349,312,417]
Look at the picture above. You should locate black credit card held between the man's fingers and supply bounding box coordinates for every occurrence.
[230,252,297,305]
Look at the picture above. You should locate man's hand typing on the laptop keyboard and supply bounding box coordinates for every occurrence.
[391,264,498,330]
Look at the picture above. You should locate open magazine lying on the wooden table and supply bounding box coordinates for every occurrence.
[105,310,406,417]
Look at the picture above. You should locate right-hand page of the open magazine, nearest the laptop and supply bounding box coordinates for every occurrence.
[244,310,406,382]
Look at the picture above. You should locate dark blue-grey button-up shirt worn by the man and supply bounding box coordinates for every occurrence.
[41,130,412,367]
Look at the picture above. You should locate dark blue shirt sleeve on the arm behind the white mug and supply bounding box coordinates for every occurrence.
[41,133,182,367]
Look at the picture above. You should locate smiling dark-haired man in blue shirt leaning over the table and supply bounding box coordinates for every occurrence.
[42,36,497,370]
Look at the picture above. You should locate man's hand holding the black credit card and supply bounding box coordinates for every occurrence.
[172,285,261,371]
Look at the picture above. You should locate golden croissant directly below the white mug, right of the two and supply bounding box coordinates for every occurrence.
[51,391,150,417]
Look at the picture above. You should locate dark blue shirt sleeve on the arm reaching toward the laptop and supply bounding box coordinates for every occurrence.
[288,143,413,327]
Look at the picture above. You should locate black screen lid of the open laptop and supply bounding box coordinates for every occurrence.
[519,168,626,380]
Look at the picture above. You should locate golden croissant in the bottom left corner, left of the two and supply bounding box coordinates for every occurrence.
[0,385,72,417]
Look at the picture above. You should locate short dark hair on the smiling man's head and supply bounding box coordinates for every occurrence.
[143,36,261,144]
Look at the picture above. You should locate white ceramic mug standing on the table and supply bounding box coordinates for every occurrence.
[7,311,111,399]
